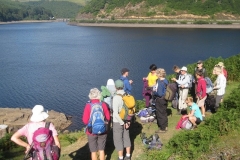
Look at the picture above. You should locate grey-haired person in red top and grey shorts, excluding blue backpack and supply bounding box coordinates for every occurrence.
[82,88,110,160]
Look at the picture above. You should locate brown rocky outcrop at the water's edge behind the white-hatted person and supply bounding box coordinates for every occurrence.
[0,108,72,133]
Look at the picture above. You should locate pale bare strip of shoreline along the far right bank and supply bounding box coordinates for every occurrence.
[68,22,240,29]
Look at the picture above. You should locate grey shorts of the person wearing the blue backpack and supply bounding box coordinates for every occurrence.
[88,134,107,152]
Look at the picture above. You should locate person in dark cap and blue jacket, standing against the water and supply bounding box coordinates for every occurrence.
[120,68,133,94]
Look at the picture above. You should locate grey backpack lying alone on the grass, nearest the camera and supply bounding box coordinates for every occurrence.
[140,133,163,150]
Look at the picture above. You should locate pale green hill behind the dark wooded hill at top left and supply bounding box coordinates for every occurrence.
[24,1,81,18]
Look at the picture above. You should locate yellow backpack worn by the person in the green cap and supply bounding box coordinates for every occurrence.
[117,94,136,121]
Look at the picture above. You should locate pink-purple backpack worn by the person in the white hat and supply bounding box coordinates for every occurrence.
[30,122,60,160]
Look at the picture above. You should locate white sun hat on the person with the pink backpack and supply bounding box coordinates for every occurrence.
[30,105,49,122]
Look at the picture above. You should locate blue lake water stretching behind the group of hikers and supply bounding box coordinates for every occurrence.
[0,23,240,130]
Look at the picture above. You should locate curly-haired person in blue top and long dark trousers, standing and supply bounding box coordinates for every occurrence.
[153,68,168,133]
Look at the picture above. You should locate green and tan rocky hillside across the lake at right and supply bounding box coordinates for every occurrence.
[81,0,240,17]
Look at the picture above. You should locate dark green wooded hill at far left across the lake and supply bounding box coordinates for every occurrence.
[0,0,53,22]
